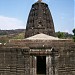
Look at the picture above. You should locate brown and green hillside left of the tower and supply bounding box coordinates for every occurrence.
[0,29,25,43]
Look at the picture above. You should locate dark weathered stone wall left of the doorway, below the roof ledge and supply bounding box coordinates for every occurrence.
[0,48,30,75]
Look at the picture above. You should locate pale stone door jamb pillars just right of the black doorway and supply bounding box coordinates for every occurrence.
[46,55,58,75]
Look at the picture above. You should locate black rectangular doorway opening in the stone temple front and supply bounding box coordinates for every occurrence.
[37,56,46,75]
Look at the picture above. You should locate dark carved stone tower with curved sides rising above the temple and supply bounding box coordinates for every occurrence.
[25,0,55,38]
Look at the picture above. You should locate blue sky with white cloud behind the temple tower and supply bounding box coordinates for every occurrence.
[0,0,75,33]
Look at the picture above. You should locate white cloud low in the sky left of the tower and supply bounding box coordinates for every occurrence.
[0,16,25,30]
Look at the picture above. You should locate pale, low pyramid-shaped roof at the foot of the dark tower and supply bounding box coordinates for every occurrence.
[26,33,59,40]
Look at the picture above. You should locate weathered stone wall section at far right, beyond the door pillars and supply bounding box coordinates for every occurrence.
[58,47,75,75]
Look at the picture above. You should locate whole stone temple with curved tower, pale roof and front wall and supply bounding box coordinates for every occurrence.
[0,0,75,75]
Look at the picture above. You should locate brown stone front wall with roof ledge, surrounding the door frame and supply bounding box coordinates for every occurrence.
[0,40,75,75]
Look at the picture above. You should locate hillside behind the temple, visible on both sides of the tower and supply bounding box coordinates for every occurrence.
[0,29,73,43]
